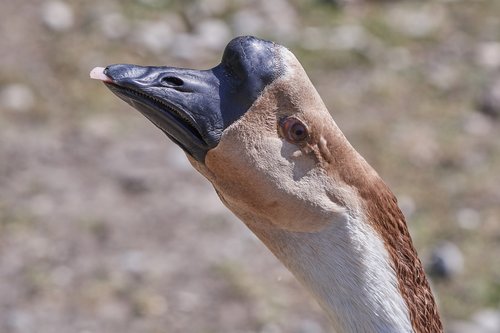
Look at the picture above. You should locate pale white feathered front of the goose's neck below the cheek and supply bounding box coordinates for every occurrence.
[249,211,412,333]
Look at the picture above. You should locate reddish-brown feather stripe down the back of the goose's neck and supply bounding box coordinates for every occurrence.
[316,131,443,333]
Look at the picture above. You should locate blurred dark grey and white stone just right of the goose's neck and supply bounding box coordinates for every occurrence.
[428,242,464,279]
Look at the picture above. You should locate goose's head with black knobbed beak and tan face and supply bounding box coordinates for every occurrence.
[94,36,349,231]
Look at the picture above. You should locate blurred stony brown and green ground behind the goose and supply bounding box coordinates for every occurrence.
[0,0,500,333]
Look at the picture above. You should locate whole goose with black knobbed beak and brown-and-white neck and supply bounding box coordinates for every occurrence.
[90,36,443,333]
